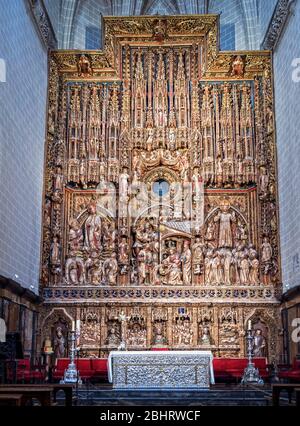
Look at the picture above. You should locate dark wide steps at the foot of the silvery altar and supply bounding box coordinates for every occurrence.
[62,386,282,406]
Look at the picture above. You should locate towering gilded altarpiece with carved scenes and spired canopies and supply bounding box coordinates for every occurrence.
[40,15,281,361]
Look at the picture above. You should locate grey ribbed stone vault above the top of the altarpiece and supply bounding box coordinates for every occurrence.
[45,0,259,49]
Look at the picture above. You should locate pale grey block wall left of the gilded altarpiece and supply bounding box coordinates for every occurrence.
[0,0,47,292]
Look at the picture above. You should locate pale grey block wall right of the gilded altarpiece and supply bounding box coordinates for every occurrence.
[273,2,300,290]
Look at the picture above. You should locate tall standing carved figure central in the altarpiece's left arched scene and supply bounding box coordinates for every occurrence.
[84,201,101,251]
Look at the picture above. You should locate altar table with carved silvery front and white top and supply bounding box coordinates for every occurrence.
[108,350,215,389]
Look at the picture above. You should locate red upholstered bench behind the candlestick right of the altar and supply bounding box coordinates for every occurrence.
[213,358,269,381]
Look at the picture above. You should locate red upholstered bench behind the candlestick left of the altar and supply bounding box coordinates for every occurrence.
[52,358,107,380]
